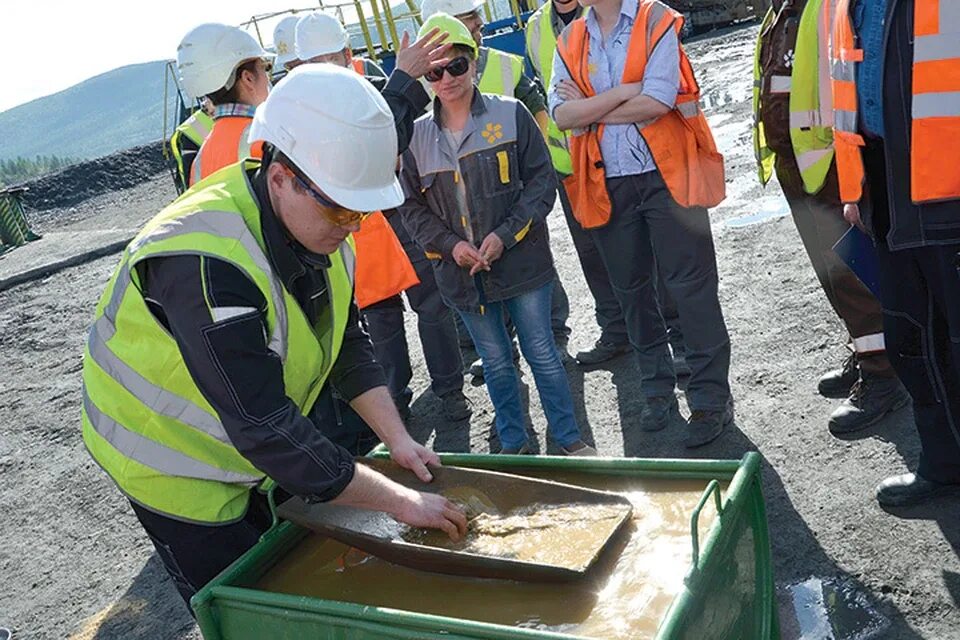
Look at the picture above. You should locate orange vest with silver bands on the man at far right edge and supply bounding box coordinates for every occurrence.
[831,0,960,204]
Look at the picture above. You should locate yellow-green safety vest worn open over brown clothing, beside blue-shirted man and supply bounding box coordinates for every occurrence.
[753,0,836,194]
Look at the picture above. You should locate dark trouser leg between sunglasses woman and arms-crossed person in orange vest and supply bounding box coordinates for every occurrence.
[557,182,627,344]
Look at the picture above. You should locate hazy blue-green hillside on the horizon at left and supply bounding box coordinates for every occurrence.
[0,60,178,160]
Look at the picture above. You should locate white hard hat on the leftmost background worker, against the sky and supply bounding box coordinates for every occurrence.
[177,22,273,98]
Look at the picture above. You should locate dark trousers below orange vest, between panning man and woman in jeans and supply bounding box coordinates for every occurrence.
[362,216,463,405]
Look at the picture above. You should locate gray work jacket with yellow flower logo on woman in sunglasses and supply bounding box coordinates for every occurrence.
[400,91,557,313]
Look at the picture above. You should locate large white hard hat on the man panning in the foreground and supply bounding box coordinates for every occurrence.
[249,64,404,211]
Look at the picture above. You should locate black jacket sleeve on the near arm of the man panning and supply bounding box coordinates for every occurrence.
[140,256,354,501]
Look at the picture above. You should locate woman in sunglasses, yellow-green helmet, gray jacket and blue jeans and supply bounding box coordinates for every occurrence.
[400,13,596,455]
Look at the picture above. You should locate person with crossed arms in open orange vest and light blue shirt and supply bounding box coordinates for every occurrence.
[548,0,733,447]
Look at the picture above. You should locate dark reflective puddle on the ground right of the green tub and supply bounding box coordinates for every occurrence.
[779,577,890,640]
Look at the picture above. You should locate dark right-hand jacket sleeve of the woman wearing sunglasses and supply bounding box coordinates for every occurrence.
[493,103,557,249]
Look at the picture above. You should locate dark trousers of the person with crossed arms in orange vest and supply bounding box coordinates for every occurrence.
[590,171,730,411]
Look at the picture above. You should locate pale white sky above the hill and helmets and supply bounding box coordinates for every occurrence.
[0,0,330,111]
